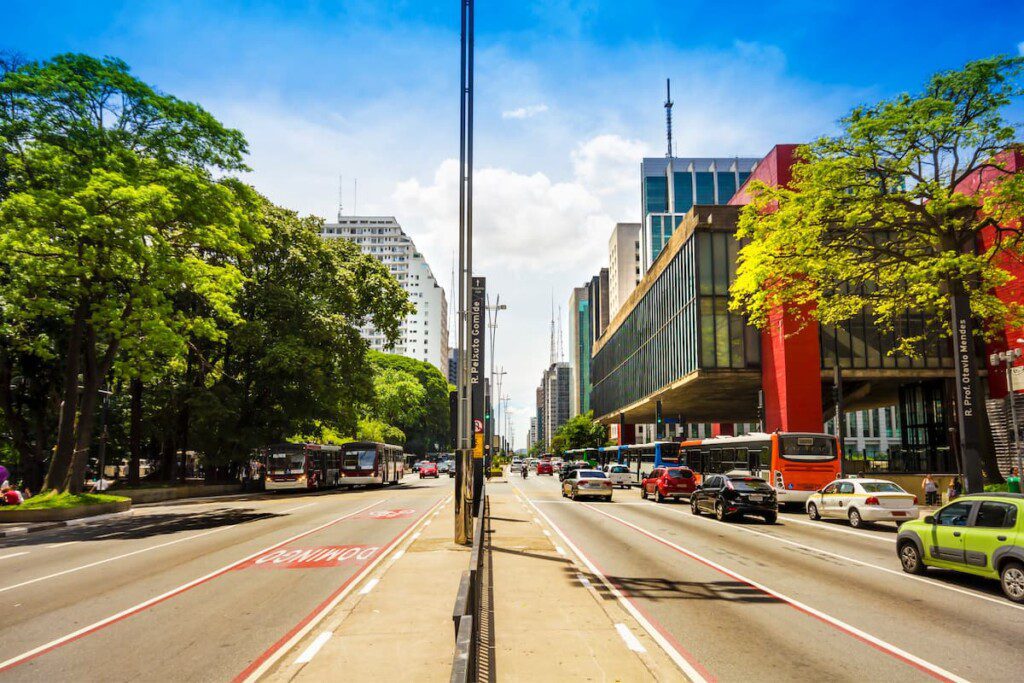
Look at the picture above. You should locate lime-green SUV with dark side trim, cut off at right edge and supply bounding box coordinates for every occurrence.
[896,494,1024,602]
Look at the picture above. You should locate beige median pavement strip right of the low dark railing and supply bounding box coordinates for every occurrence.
[487,480,685,681]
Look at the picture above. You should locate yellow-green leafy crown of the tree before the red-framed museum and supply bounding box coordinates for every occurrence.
[730,56,1024,485]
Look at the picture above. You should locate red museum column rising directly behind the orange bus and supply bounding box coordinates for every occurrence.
[761,309,824,432]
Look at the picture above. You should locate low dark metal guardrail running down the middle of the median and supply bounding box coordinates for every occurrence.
[451,487,490,683]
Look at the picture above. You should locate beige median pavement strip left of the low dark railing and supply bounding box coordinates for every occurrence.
[264,503,469,683]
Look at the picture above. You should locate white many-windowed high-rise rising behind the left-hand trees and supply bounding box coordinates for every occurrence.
[321,216,449,377]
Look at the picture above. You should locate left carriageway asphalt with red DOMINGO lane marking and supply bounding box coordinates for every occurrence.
[0,476,452,681]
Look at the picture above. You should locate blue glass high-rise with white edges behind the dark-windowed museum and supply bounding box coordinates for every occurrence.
[640,157,760,272]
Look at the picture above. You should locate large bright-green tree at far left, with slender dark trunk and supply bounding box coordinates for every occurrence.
[0,54,262,492]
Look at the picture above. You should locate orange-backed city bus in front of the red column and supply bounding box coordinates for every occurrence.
[678,432,842,504]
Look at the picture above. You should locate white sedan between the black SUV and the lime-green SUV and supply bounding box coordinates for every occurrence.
[806,478,920,527]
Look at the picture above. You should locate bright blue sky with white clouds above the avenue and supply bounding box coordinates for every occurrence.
[0,0,1024,443]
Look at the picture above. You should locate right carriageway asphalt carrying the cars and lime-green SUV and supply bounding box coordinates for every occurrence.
[512,476,1024,681]
